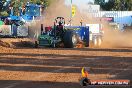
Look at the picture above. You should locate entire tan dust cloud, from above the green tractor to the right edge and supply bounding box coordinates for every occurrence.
[30,0,132,48]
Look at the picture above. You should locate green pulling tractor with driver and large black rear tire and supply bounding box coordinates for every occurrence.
[35,17,80,48]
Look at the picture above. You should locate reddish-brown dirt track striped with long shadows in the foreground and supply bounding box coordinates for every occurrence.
[0,38,132,88]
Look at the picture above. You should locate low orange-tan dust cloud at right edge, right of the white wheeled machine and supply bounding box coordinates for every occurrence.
[101,27,132,48]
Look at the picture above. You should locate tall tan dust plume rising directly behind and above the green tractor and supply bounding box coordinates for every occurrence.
[30,0,96,38]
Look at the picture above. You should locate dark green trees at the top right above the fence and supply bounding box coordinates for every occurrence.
[94,0,132,11]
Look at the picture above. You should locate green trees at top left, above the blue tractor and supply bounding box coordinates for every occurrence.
[0,0,53,16]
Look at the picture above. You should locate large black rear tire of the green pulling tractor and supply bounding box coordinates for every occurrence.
[63,30,78,48]
